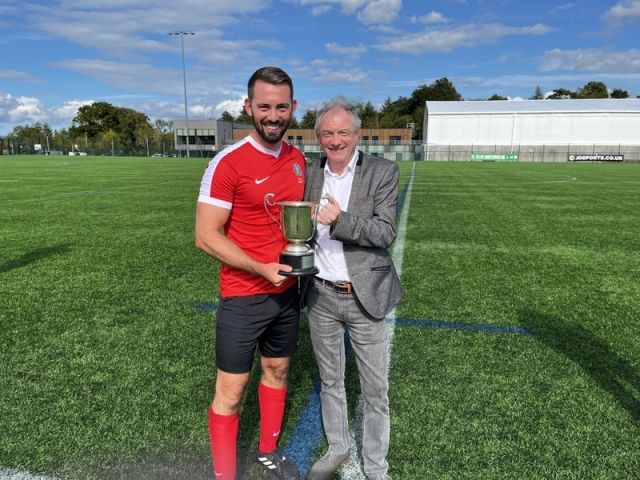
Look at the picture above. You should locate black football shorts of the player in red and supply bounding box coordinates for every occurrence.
[216,286,300,373]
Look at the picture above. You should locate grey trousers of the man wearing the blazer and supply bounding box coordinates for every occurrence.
[307,280,390,477]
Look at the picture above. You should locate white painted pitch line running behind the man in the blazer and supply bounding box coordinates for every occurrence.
[341,162,416,480]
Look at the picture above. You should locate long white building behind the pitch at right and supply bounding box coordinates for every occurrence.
[423,99,640,161]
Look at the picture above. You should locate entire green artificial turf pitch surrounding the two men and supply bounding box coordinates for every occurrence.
[0,156,640,480]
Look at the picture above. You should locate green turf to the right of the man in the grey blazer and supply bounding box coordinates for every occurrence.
[390,163,640,479]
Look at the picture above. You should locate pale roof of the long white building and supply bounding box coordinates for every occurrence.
[426,98,640,115]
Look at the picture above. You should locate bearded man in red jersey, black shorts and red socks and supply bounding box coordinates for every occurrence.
[195,67,305,480]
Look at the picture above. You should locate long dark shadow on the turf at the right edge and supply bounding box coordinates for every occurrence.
[520,310,640,421]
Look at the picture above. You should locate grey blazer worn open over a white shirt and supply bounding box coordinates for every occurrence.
[304,151,403,318]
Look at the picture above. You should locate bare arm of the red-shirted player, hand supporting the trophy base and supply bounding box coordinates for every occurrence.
[195,202,291,285]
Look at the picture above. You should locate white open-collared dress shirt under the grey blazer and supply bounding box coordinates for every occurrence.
[315,150,358,282]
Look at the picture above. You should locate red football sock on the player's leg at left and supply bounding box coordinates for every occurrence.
[209,408,240,480]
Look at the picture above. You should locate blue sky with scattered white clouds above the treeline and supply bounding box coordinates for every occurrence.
[0,0,640,135]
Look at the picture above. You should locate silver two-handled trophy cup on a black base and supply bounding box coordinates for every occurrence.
[264,193,328,277]
